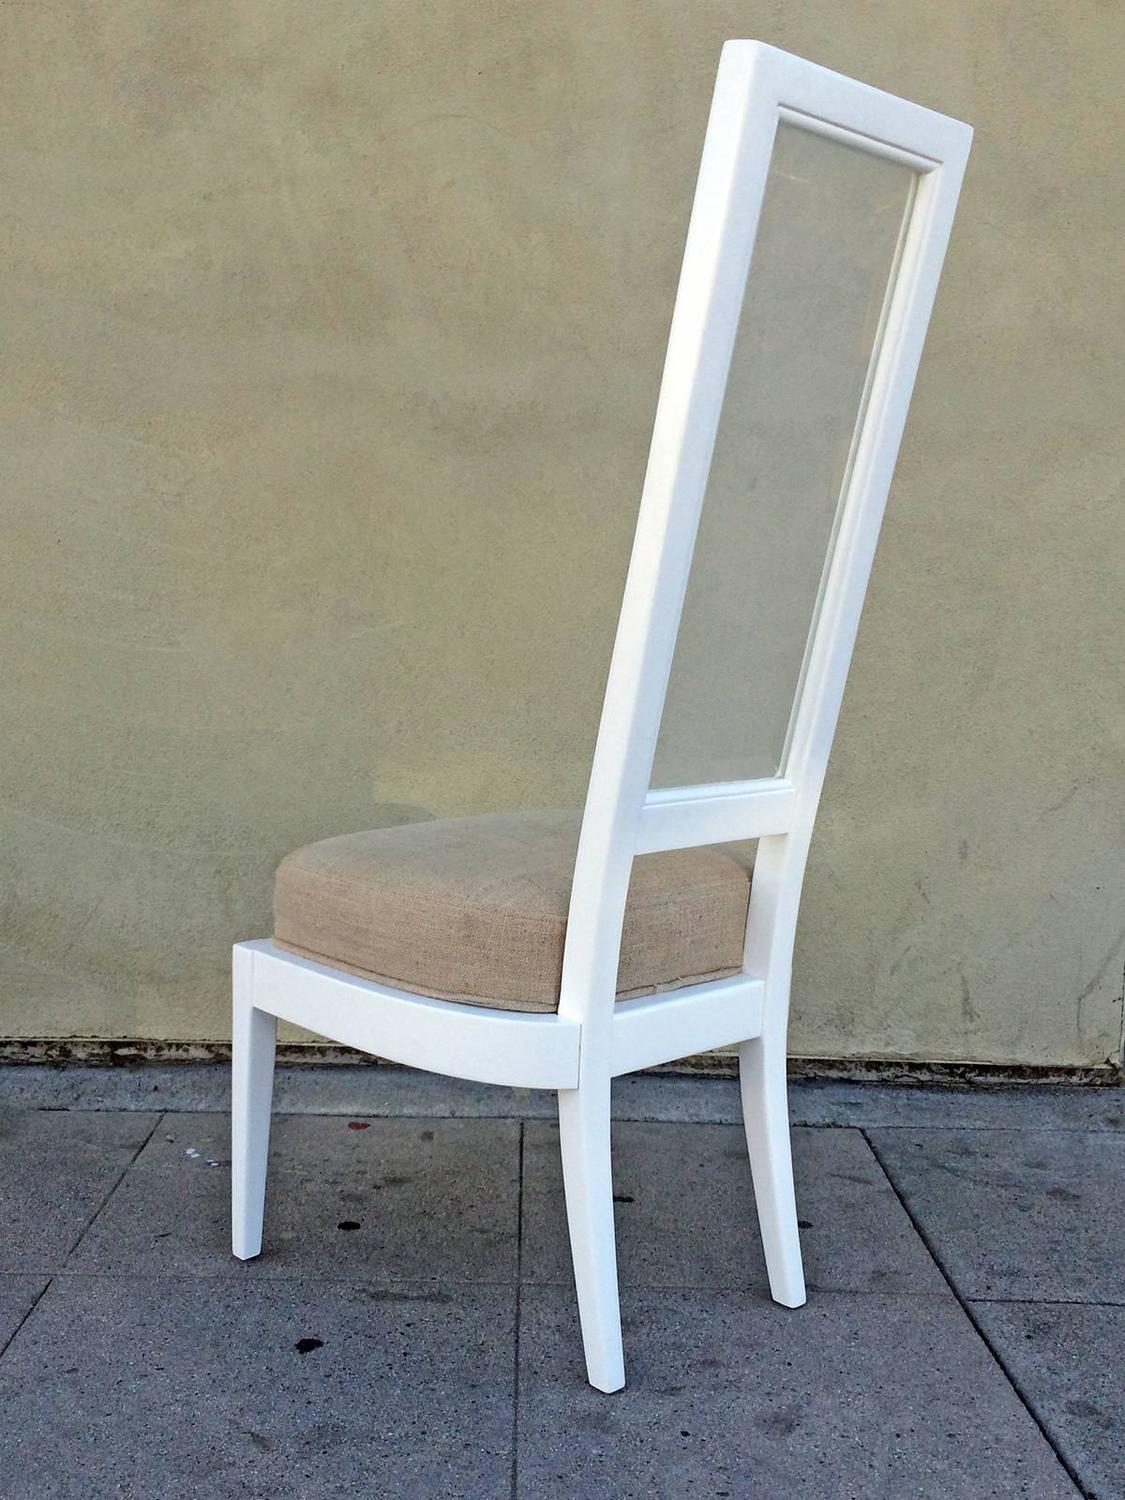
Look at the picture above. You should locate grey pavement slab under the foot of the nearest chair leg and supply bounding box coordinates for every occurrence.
[518,1287,1079,1500]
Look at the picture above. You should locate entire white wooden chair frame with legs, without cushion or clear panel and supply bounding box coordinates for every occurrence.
[236,42,972,1391]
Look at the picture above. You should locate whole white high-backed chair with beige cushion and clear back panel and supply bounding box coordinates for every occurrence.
[233,42,972,1391]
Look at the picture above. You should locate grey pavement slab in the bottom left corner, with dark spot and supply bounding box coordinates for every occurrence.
[0,1277,515,1500]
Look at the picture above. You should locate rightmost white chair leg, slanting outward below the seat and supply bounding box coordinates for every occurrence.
[738,1037,806,1308]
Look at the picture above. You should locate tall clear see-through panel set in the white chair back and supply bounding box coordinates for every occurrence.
[653,125,915,786]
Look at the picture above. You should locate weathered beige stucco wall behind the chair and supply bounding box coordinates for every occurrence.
[0,0,1125,1064]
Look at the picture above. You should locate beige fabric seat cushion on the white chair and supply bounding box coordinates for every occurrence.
[275,812,750,1011]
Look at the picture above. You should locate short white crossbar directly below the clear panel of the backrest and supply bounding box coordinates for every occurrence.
[636,777,797,854]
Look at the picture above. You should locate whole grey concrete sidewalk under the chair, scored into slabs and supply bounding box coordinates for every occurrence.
[0,1068,1125,1500]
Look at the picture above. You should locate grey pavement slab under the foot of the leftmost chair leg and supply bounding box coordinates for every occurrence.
[68,1115,521,1281]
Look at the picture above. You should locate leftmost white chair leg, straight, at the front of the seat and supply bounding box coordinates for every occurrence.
[231,948,278,1260]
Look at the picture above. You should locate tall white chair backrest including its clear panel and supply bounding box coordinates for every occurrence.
[560,42,972,1058]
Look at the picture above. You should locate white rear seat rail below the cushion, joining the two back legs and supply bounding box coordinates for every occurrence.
[609,974,765,1079]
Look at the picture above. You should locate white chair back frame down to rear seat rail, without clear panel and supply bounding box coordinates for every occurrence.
[560,41,972,1082]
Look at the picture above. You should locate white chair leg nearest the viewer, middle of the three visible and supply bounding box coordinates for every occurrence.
[558,1079,626,1392]
